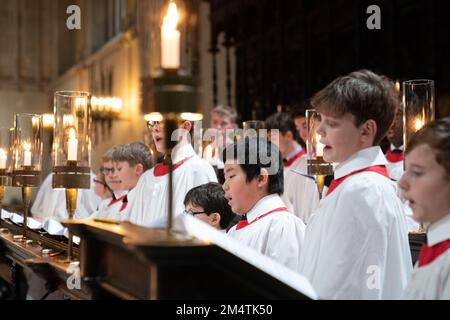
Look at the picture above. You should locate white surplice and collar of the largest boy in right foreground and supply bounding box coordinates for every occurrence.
[300,147,412,299]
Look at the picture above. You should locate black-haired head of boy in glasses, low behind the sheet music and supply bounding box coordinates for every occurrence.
[184,182,236,231]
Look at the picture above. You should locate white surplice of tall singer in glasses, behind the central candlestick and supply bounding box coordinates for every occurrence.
[121,144,217,226]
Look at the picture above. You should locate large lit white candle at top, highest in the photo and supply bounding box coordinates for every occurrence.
[161,2,180,69]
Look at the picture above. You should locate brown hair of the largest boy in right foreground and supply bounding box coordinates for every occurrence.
[311,70,400,145]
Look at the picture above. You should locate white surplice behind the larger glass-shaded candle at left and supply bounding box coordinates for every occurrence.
[31,173,101,221]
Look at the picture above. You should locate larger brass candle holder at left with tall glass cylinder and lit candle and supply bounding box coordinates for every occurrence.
[52,91,92,262]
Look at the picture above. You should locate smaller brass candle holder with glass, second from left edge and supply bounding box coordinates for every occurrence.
[12,114,42,241]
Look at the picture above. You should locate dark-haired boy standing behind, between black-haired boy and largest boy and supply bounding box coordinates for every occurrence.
[266,112,319,223]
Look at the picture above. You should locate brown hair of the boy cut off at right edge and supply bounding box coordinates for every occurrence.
[406,117,450,180]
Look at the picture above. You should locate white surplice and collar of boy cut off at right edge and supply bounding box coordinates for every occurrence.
[404,213,450,300]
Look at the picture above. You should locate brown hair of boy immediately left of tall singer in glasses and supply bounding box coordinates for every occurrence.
[112,142,152,171]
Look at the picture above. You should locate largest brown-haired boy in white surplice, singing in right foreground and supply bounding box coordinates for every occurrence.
[300,70,412,299]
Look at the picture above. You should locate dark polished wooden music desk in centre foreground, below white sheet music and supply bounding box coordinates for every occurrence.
[65,220,312,300]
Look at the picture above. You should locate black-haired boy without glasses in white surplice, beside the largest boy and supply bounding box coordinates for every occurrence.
[223,137,305,271]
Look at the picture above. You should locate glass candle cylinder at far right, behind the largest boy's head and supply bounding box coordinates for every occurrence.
[402,79,435,151]
